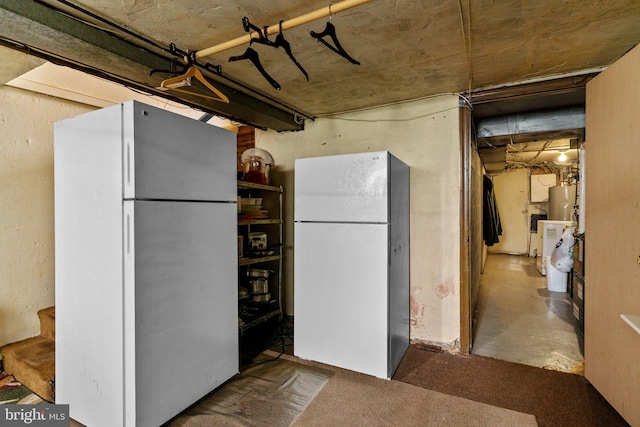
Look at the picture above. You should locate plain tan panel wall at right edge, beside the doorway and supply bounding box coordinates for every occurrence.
[584,42,640,426]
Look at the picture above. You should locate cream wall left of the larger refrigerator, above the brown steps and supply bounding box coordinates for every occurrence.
[0,86,94,345]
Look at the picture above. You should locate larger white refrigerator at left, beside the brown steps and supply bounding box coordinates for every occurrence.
[54,102,239,427]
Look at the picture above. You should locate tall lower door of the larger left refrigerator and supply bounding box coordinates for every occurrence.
[124,201,238,426]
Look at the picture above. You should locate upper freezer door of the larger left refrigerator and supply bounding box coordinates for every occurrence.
[122,101,237,201]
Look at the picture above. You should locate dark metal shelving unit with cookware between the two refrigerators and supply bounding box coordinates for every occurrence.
[238,181,284,334]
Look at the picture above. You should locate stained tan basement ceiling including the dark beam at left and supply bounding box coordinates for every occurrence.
[0,0,640,131]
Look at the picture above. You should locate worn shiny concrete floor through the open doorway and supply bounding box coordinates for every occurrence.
[472,254,584,374]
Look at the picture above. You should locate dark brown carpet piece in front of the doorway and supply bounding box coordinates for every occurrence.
[393,345,628,427]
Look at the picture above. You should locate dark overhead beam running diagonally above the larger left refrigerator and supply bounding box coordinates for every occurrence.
[0,0,304,131]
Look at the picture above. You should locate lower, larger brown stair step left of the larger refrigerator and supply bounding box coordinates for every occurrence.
[0,336,56,402]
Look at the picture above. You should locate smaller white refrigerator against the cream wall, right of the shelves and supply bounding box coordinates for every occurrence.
[294,151,409,379]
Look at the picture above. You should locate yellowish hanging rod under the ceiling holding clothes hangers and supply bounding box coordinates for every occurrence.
[195,0,371,59]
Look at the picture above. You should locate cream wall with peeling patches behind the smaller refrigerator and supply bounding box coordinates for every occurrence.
[256,95,460,344]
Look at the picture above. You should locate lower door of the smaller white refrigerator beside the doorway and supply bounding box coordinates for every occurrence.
[294,223,389,378]
